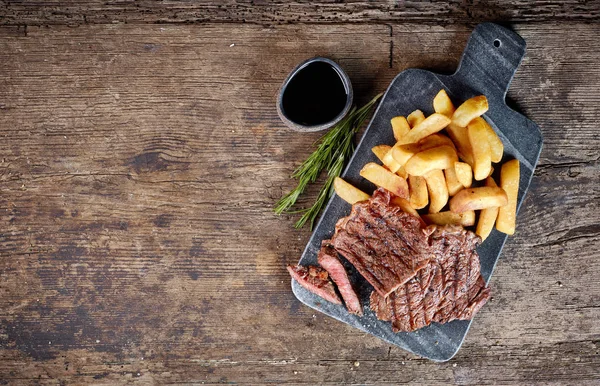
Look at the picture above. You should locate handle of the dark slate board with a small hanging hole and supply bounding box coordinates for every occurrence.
[454,23,526,99]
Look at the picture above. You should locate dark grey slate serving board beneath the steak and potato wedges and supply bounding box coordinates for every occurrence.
[292,23,542,361]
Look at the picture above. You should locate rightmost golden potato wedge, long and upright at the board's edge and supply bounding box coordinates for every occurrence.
[496,159,521,235]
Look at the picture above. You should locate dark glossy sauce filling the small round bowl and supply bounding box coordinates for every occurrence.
[281,62,348,126]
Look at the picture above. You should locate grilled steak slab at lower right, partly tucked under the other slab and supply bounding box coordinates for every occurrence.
[371,226,490,332]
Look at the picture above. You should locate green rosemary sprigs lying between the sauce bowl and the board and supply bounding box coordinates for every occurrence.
[275,94,382,229]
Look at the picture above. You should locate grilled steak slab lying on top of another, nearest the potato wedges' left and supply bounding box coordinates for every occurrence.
[331,189,432,297]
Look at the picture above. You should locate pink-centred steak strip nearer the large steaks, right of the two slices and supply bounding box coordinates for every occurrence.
[318,240,362,316]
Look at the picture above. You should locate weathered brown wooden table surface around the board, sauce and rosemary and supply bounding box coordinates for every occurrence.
[0,0,600,385]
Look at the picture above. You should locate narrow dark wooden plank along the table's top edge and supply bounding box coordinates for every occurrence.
[0,0,600,25]
